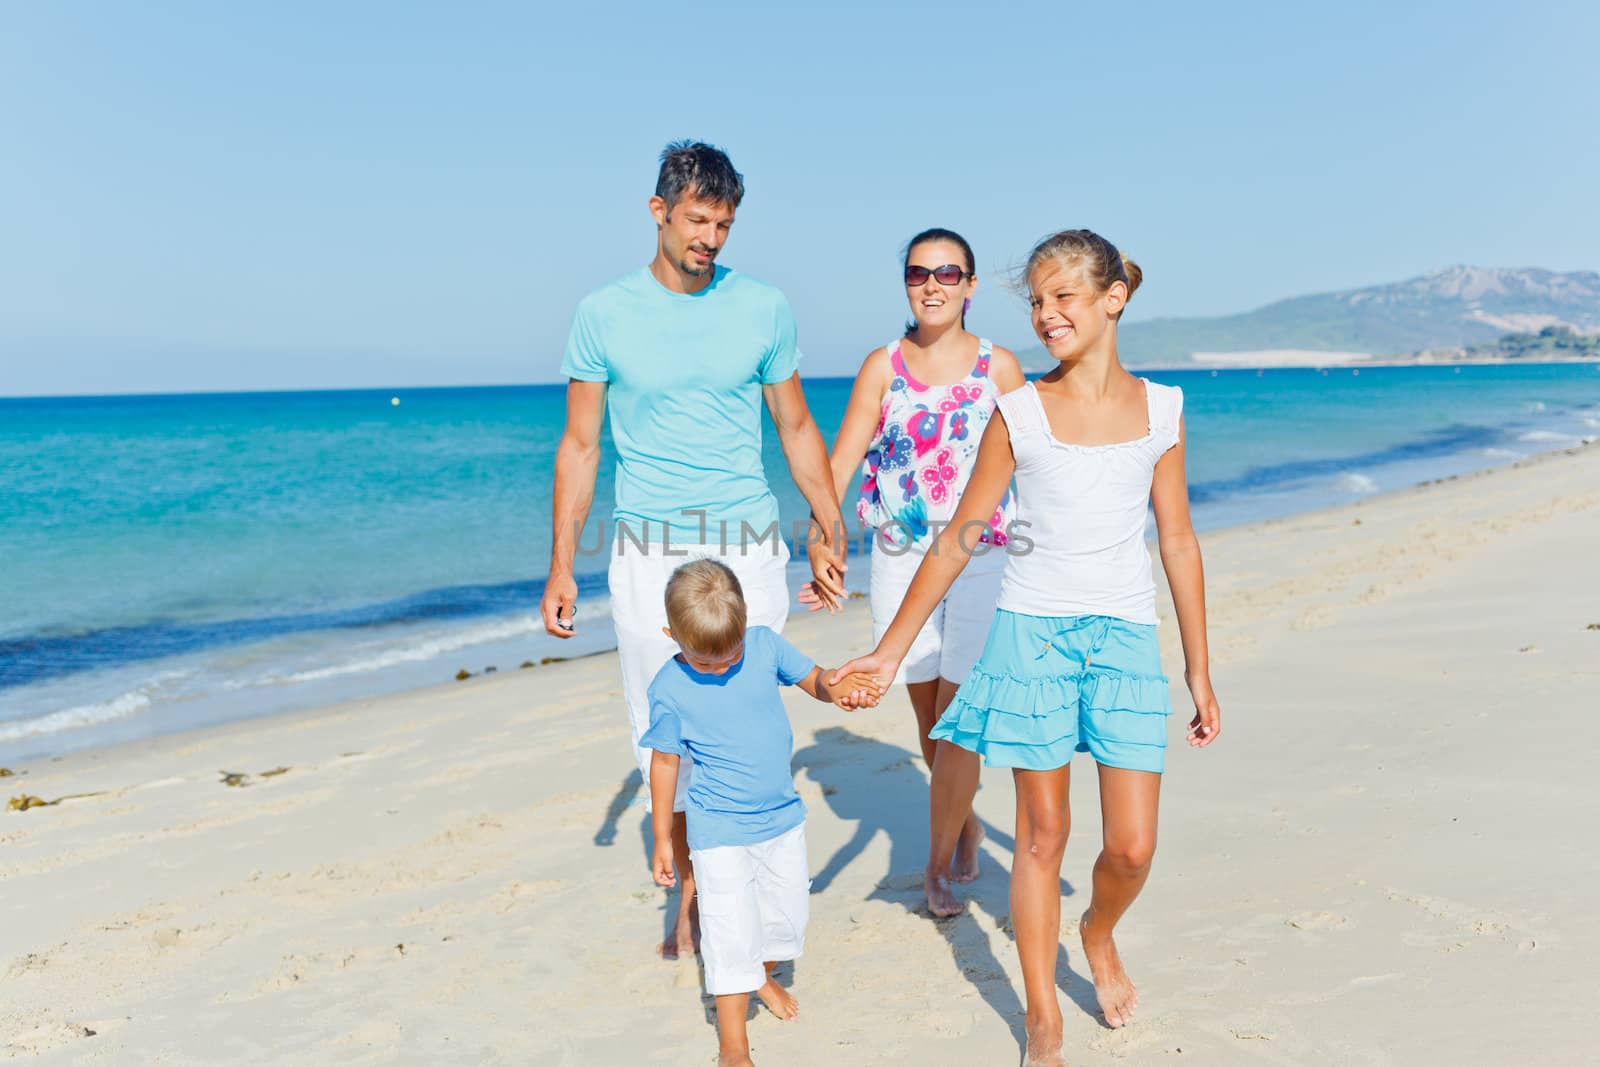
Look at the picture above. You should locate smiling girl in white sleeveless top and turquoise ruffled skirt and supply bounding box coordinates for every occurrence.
[838,230,1221,1067]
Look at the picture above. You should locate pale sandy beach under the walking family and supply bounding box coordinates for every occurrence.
[0,446,1600,1067]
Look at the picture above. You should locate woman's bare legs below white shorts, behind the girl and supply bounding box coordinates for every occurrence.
[906,678,984,918]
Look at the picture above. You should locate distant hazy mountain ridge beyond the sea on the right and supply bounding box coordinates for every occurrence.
[1021,267,1600,371]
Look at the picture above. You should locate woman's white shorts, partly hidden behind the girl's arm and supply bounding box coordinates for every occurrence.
[870,536,1006,685]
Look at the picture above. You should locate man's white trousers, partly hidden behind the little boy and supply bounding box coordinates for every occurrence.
[608,541,789,811]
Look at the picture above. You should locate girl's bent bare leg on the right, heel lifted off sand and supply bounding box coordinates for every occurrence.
[1078,765,1162,1027]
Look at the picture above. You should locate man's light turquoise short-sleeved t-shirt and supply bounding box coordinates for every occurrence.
[562,267,812,544]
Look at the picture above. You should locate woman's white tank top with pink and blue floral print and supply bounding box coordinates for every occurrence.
[856,338,1013,545]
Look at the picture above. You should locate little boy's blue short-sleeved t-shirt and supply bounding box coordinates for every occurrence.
[638,625,816,849]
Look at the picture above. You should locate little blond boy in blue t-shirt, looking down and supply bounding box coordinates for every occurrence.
[640,560,882,1067]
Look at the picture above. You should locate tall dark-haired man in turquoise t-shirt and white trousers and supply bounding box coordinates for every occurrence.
[541,141,845,957]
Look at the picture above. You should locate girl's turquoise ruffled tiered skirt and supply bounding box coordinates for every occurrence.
[928,609,1173,773]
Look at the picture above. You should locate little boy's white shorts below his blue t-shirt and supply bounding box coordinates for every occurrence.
[690,822,811,997]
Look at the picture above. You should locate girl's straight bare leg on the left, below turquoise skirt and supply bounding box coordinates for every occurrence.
[1011,765,1072,1067]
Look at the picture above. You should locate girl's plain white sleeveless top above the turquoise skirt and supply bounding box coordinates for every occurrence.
[997,378,1184,624]
